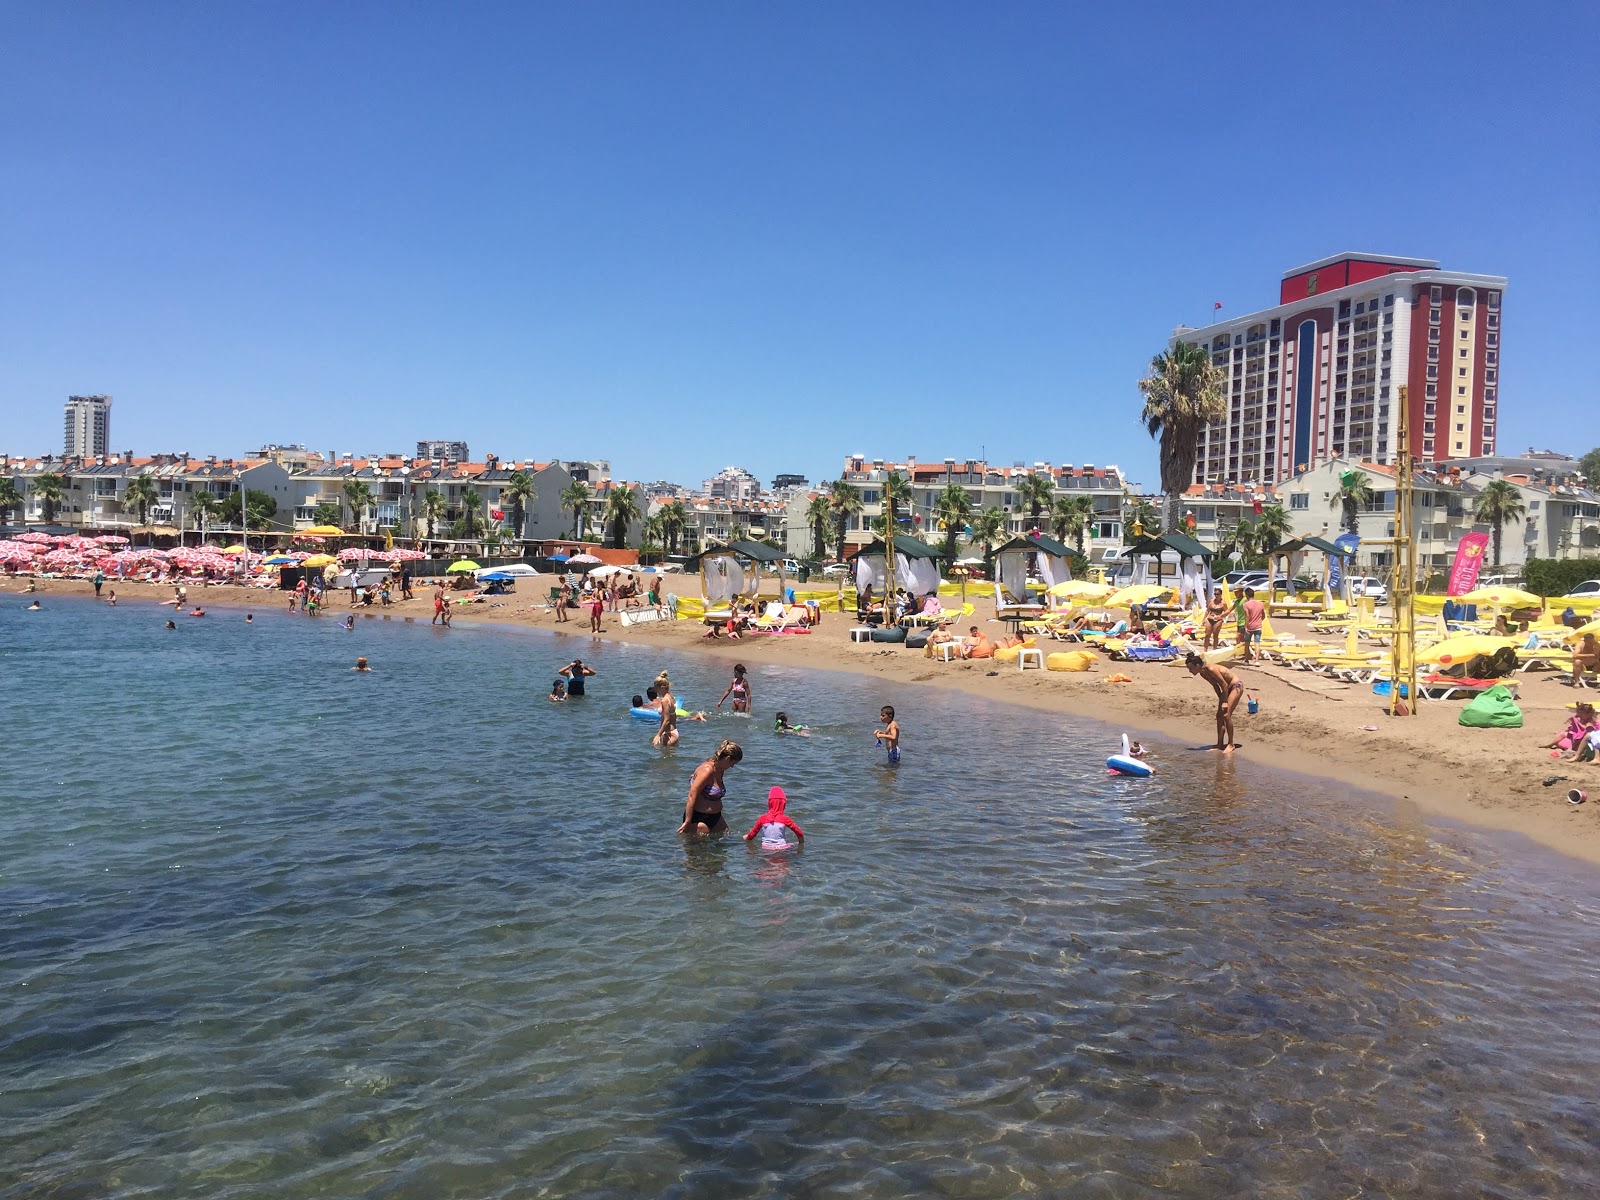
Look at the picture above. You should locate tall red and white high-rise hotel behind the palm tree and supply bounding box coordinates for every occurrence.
[1173,254,1506,485]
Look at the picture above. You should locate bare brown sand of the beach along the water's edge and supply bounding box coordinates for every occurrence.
[15,576,1600,864]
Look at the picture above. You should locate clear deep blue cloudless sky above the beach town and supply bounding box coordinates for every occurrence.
[0,0,1600,486]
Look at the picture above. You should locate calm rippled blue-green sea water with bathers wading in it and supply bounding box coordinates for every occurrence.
[0,594,1600,1200]
